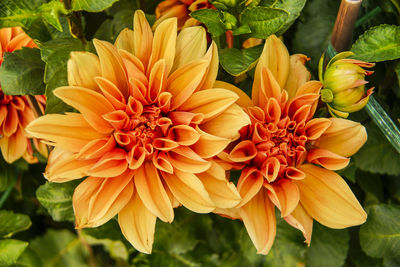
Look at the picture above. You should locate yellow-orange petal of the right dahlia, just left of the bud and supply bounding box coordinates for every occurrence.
[284,54,311,99]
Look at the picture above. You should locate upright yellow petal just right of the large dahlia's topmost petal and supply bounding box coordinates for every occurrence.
[147,18,177,75]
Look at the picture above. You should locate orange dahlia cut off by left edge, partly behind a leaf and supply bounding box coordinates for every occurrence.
[0,27,47,163]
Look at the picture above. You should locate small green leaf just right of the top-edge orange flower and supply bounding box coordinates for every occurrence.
[190,9,225,37]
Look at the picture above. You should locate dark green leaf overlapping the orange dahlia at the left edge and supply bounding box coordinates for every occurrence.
[0,47,45,95]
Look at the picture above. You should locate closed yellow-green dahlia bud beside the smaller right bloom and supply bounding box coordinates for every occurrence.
[319,52,375,118]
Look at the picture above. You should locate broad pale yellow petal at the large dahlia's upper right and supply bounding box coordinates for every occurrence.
[172,26,207,70]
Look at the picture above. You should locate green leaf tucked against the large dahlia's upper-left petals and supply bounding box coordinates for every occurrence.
[41,38,85,113]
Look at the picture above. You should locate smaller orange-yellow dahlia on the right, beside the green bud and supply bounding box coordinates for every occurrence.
[217,36,367,254]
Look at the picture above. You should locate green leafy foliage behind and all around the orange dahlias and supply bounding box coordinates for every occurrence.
[0,0,400,267]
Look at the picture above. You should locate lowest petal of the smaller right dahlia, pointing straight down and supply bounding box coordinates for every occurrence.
[239,189,276,254]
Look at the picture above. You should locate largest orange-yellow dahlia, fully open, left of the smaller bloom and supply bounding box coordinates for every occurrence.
[28,11,250,253]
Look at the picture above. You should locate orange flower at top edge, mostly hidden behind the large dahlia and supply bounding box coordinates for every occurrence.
[153,0,214,30]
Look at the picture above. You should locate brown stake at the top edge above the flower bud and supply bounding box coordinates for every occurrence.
[331,0,362,52]
